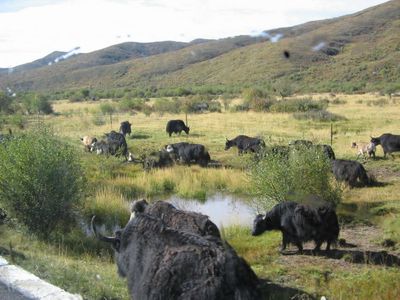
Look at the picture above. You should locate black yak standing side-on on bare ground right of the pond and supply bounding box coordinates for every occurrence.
[252,201,339,252]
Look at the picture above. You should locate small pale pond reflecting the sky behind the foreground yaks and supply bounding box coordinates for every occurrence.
[167,194,256,228]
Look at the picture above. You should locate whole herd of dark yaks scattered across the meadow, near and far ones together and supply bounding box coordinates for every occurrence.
[81,120,400,300]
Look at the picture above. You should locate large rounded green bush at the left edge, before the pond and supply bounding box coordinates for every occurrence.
[0,129,84,238]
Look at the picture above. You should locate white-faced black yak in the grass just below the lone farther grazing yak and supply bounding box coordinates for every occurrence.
[165,142,211,167]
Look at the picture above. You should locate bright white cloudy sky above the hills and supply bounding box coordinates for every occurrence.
[0,0,386,68]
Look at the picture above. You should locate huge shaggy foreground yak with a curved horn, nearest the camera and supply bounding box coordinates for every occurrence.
[92,213,260,300]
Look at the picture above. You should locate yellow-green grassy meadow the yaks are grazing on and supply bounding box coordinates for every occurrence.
[0,94,400,299]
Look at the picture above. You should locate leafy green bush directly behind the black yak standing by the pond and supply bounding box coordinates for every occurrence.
[249,147,341,210]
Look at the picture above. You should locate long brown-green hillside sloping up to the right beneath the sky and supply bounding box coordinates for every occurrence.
[0,1,400,92]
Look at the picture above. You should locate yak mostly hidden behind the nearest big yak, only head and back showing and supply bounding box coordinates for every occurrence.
[131,199,221,237]
